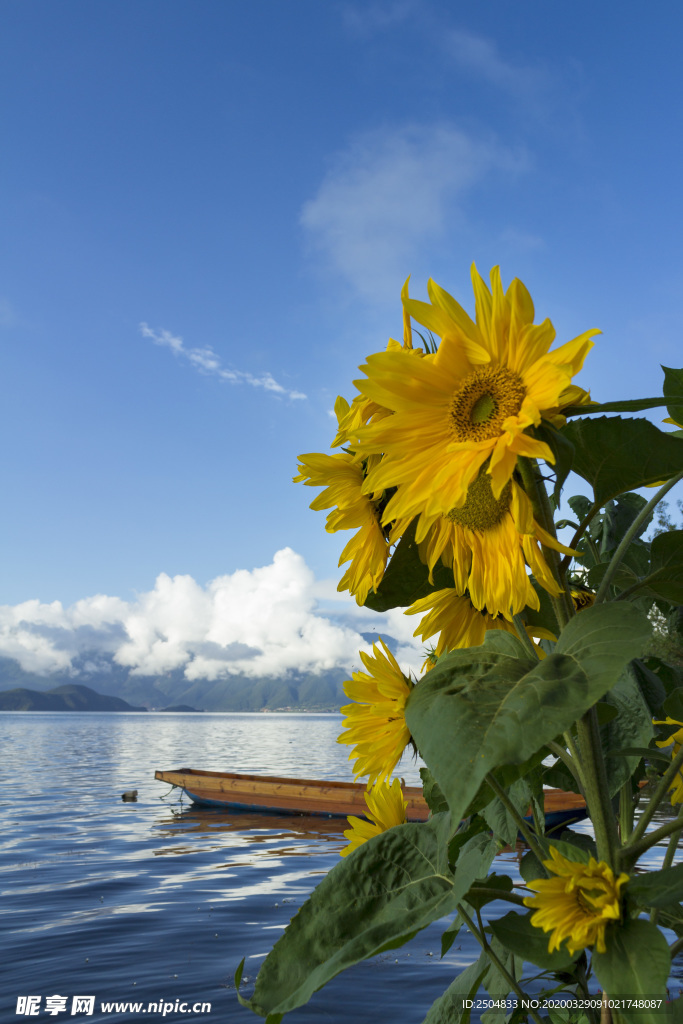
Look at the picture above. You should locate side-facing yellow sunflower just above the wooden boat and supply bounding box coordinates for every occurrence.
[337,637,414,785]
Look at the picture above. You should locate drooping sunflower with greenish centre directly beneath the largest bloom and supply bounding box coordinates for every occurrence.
[416,472,575,618]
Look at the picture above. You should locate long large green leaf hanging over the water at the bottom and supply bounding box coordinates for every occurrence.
[241,819,496,1017]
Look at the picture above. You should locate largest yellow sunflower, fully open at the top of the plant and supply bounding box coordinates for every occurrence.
[354,266,599,521]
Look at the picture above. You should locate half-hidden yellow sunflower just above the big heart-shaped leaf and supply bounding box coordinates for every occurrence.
[405,588,515,660]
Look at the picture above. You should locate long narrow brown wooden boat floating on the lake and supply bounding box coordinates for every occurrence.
[155,768,586,828]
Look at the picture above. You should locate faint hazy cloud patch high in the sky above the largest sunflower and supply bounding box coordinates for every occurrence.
[301,123,525,299]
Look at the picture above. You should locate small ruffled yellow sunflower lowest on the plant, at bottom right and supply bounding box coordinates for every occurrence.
[524,847,629,955]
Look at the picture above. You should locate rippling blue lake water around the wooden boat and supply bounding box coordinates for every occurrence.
[0,713,679,1024]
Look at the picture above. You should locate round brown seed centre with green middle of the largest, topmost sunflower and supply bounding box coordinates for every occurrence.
[449,367,526,441]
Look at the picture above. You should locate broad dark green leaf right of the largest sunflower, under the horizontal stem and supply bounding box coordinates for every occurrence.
[563,416,683,505]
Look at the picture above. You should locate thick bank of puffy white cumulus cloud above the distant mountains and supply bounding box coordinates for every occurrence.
[0,548,428,680]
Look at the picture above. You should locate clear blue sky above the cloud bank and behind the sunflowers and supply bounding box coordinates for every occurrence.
[0,0,683,684]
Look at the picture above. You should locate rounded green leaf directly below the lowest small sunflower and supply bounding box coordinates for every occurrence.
[593,920,671,1024]
